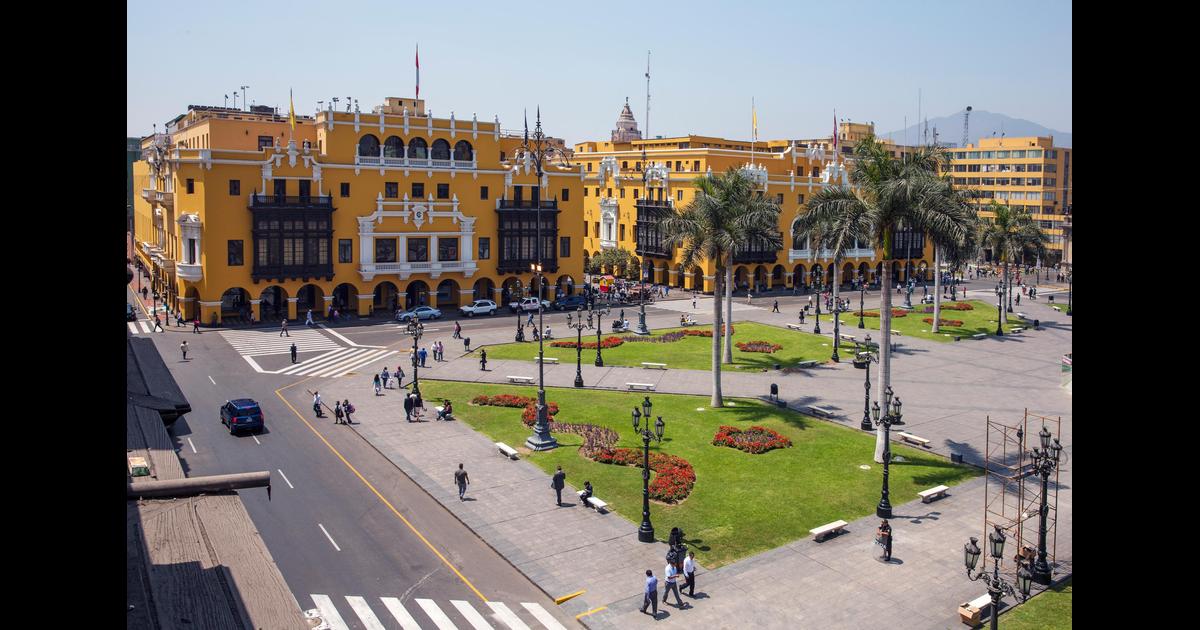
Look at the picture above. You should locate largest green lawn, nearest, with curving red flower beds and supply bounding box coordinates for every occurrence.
[421,380,979,569]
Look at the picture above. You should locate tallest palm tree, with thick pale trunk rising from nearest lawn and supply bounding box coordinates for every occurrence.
[806,136,967,463]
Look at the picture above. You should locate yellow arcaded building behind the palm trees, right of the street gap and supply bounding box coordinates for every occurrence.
[568,103,932,292]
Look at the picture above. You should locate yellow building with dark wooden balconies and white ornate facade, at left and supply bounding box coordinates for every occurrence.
[133,97,584,325]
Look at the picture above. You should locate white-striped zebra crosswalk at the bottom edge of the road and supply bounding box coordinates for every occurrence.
[305,594,566,630]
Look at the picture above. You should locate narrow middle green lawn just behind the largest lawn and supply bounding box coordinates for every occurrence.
[472,316,859,370]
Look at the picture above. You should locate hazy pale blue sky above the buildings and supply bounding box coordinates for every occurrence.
[126,0,1072,143]
